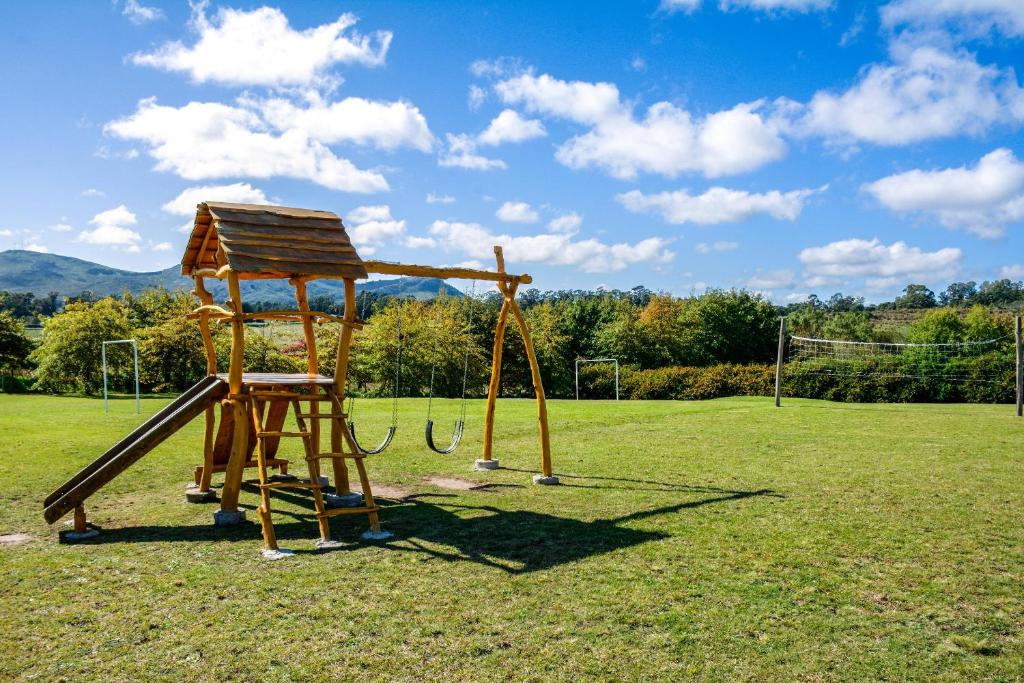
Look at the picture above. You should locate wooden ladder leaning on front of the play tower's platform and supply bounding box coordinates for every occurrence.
[249,386,390,557]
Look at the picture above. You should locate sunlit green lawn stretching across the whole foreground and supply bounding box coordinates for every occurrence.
[0,395,1024,681]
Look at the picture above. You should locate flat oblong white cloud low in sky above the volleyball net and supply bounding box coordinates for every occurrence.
[800,238,961,287]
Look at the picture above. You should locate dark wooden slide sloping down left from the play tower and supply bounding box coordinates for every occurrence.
[43,375,227,524]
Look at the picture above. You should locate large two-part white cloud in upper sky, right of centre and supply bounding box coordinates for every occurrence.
[495,74,785,179]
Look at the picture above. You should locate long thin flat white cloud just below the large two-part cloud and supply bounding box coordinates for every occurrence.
[615,187,823,225]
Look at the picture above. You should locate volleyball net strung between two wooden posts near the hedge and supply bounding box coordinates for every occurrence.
[775,316,1024,416]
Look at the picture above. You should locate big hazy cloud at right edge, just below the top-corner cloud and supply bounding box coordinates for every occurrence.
[778,40,1024,146]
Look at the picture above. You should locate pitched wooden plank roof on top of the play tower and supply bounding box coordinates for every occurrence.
[181,202,367,280]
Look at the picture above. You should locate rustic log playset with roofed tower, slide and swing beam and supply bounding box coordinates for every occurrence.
[44,202,558,557]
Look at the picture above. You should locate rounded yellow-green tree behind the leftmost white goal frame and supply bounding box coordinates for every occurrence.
[31,297,131,393]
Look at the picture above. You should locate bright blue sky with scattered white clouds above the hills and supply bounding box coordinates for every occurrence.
[0,0,1024,302]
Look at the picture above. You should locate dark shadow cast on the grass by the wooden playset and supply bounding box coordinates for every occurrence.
[86,489,778,574]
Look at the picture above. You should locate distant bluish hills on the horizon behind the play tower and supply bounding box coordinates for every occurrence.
[0,249,462,303]
